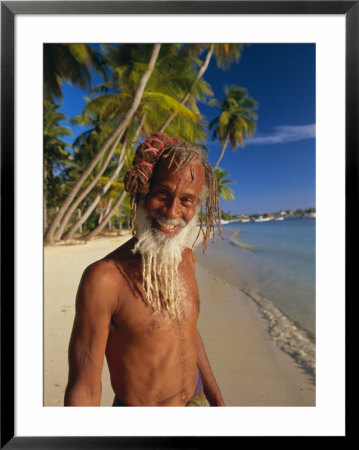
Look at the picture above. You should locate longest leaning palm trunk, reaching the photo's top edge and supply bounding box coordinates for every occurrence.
[45,44,161,243]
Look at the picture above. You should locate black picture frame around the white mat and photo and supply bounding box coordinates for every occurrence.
[0,1,359,449]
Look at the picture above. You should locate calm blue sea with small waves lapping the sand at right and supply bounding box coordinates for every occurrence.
[196,217,316,374]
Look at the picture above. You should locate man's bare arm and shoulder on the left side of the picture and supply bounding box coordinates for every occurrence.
[65,262,117,406]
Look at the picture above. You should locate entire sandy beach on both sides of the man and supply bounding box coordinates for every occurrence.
[44,233,315,406]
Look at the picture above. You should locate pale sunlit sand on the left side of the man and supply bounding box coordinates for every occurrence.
[44,232,131,406]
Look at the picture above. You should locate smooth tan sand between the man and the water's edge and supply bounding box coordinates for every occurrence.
[196,264,315,406]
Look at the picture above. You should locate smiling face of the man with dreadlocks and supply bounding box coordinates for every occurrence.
[145,158,205,237]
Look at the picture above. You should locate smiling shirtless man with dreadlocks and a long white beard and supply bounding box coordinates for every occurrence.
[65,133,224,406]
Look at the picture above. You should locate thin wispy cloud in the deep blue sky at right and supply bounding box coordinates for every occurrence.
[246,124,315,145]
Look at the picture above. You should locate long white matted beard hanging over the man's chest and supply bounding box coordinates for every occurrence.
[133,201,198,319]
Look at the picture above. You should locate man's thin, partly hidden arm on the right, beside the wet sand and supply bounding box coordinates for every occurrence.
[197,330,225,406]
